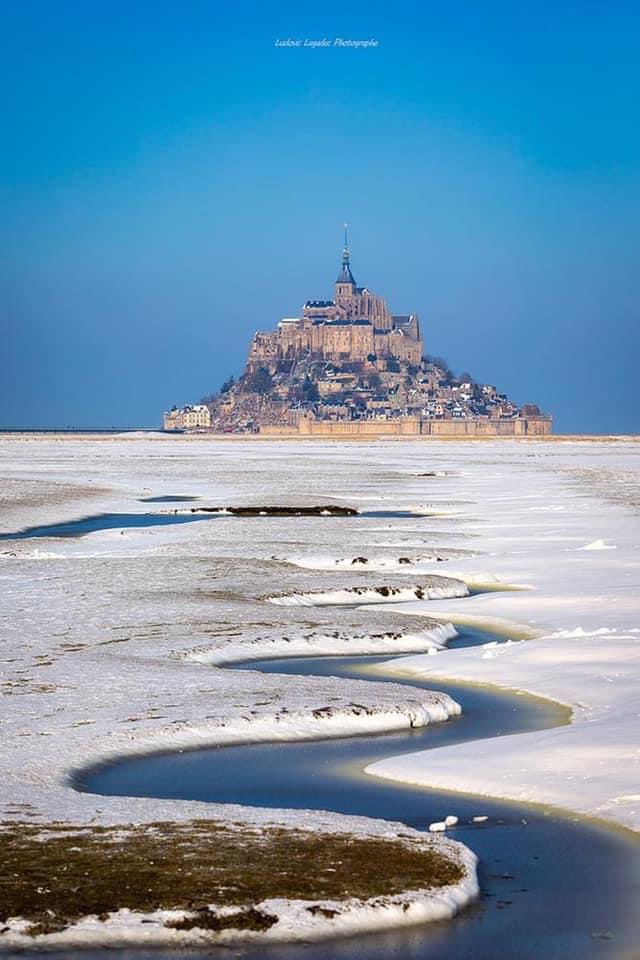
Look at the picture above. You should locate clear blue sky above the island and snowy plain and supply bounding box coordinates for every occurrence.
[0,0,640,432]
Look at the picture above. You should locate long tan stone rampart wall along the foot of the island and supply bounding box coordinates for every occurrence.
[260,417,552,437]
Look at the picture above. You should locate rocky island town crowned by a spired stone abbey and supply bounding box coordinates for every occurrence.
[164,231,552,436]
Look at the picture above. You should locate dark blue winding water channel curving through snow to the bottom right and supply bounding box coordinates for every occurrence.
[78,628,640,960]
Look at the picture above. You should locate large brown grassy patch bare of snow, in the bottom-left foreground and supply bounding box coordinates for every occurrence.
[0,820,463,940]
